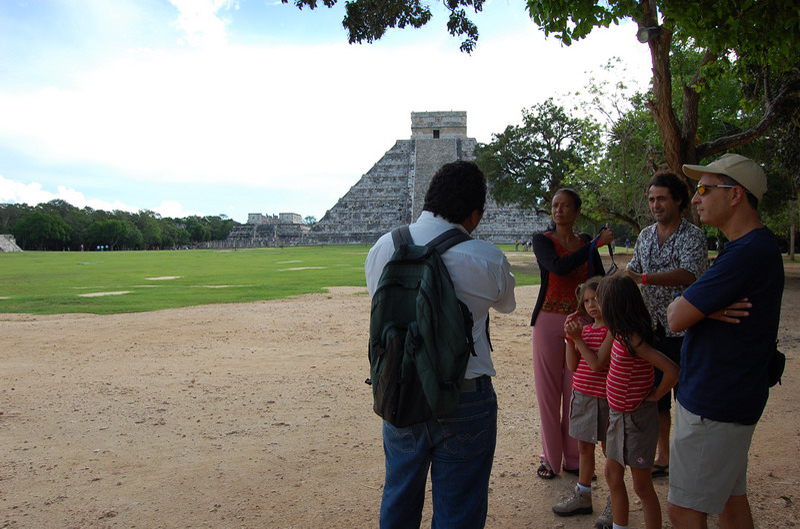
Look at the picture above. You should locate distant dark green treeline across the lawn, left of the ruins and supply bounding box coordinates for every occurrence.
[0,199,238,251]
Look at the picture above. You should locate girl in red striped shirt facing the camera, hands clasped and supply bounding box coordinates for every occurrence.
[553,277,612,516]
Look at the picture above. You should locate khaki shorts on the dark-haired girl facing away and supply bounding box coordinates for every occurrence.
[606,401,656,468]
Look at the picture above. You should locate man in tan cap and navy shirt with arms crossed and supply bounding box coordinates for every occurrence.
[667,154,784,528]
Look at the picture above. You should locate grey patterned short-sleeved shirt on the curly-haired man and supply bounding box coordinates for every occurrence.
[628,219,708,337]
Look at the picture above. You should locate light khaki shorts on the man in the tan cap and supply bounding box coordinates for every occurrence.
[667,402,756,514]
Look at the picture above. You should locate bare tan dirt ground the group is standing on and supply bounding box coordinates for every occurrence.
[0,253,800,529]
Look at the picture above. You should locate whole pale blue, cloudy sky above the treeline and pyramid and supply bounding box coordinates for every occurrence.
[0,0,650,223]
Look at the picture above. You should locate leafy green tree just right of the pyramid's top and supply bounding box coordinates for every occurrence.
[475,99,600,210]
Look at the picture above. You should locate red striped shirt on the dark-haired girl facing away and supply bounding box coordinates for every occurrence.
[606,339,654,413]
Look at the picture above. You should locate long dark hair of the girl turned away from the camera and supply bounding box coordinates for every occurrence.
[597,274,655,356]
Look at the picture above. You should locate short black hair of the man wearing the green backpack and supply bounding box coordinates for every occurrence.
[422,160,486,224]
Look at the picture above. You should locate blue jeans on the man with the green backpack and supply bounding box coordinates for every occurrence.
[381,377,497,529]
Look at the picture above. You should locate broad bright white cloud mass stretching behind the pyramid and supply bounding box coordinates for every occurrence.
[0,0,649,221]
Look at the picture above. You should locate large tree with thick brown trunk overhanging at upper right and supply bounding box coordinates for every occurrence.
[528,0,800,174]
